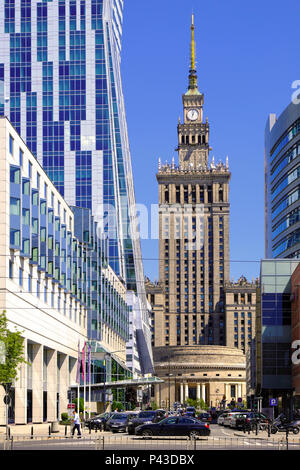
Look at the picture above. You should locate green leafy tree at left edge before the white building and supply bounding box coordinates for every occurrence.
[0,310,28,385]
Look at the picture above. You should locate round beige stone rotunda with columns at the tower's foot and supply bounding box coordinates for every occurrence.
[154,346,246,407]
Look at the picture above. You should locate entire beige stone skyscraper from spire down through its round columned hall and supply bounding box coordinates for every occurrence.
[146,16,246,406]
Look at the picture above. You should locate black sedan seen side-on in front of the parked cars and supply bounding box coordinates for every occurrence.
[135,416,210,437]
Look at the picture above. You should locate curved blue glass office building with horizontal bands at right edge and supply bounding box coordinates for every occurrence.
[265,102,300,258]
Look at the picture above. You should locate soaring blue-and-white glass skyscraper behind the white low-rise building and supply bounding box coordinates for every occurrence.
[0,0,152,372]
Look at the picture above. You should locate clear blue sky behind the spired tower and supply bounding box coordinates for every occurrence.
[122,0,300,279]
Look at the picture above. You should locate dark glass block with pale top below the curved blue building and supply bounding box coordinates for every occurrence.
[256,259,299,412]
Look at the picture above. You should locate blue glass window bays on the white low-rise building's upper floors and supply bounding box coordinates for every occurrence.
[9,151,130,341]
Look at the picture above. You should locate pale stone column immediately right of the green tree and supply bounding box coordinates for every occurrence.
[31,344,44,423]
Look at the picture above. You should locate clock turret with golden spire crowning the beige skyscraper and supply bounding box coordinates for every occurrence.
[177,16,209,169]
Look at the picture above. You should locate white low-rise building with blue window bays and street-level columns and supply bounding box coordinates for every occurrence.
[0,117,132,424]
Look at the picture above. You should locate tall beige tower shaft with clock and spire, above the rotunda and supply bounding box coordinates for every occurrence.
[154,17,230,347]
